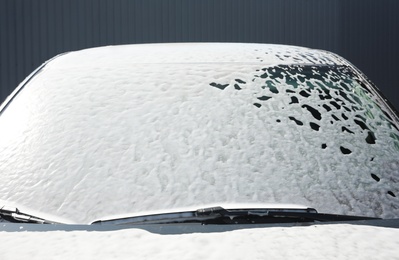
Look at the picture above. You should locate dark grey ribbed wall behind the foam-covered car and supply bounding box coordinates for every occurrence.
[0,0,399,108]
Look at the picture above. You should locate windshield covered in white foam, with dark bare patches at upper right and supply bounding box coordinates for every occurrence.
[0,50,399,223]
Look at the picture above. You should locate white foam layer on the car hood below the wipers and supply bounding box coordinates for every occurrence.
[0,224,399,260]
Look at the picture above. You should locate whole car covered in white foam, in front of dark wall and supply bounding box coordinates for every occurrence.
[0,43,399,258]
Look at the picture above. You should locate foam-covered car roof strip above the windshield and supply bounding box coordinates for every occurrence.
[52,43,341,67]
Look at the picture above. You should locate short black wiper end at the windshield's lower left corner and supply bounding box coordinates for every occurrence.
[0,206,60,224]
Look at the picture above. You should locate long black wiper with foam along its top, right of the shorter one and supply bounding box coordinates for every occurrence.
[91,207,379,225]
